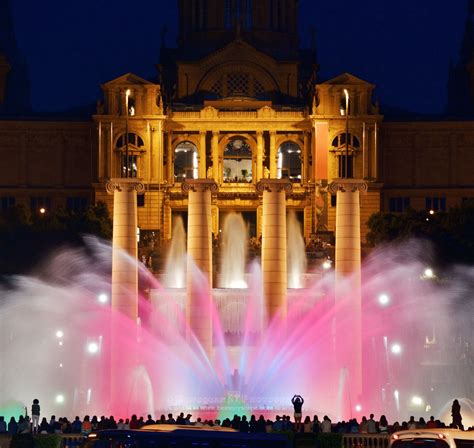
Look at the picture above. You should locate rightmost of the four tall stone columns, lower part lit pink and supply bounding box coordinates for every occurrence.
[329,179,367,415]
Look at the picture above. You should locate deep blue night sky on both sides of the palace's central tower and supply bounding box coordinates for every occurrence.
[11,0,467,113]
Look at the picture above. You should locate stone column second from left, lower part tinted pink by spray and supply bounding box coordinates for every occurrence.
[182,179,217,355]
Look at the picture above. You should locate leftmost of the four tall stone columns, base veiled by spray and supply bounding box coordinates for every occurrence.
[106,178,145,321]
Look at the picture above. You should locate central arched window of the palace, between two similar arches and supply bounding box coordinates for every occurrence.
[224,137,252,183]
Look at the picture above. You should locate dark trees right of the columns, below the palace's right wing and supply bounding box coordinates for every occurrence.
[367,201,474,263]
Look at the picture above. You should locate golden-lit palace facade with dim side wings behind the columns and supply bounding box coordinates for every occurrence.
[0,0,474,247]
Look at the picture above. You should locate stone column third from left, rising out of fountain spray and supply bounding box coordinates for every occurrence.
[257,179,292,322]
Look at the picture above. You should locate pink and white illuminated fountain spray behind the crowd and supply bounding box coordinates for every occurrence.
[0,239,474,421]
